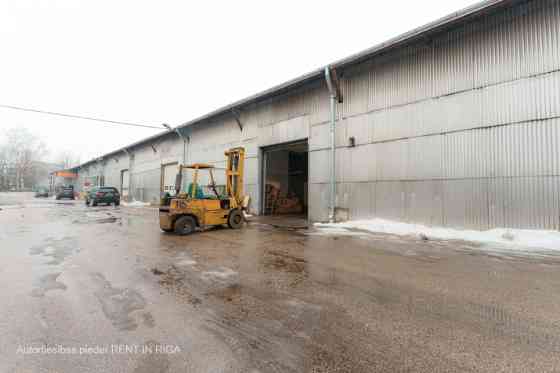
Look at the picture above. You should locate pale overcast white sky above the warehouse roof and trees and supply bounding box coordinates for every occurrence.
[0,0,477,162]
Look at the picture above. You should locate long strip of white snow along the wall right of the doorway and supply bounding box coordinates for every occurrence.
[315,219,560,250]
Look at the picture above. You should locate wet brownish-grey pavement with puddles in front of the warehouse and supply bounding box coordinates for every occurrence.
[0,194,560,373]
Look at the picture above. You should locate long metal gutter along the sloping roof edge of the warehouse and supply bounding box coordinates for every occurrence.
[79,0,516,167]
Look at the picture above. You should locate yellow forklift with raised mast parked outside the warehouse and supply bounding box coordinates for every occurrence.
[159,148,247,235]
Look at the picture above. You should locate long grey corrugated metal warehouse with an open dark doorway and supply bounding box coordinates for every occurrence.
[78,0,560,229]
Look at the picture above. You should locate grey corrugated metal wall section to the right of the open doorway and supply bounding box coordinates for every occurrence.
[310,0,560,229]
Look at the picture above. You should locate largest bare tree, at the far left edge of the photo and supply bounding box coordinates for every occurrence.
[0,127,48,190]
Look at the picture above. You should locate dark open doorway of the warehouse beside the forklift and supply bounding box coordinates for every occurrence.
[262,140,308,217]
